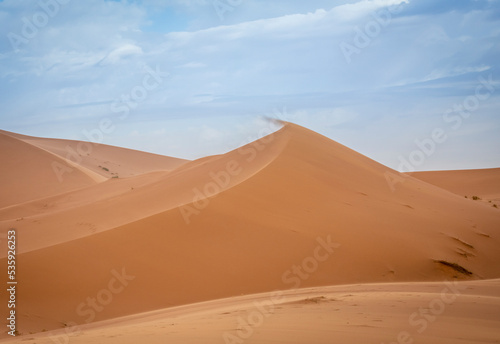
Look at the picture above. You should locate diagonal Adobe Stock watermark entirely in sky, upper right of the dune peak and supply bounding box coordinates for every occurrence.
[339,0,408,64]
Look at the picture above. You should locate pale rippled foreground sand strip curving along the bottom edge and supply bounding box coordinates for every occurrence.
[2,280,500,344]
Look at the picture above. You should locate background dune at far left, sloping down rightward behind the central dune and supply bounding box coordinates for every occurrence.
[0,130,186,208]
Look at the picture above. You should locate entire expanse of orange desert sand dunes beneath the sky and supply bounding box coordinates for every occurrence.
[0,123,500,343]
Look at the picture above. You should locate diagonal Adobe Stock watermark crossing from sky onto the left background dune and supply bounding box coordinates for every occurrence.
[51,65,170,182]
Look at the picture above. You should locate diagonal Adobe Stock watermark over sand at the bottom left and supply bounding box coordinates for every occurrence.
[50,268,135,344]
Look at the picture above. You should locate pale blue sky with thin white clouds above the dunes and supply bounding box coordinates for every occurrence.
[0,0,500,171]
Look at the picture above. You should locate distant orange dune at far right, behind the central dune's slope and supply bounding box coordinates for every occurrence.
[411,168,500,201]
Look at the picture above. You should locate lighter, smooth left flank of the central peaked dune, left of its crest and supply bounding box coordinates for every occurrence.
[0,125,286,252]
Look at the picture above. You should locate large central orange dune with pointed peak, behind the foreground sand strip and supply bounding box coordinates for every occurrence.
[0,124,500,333]
